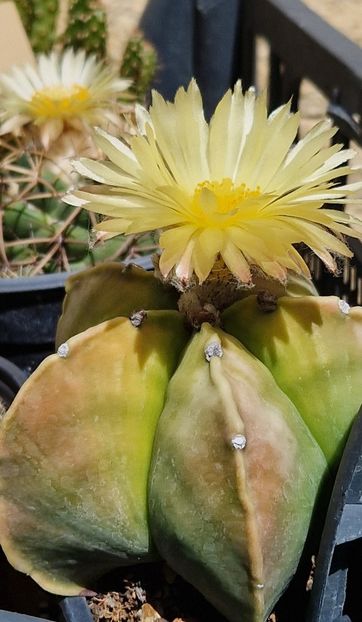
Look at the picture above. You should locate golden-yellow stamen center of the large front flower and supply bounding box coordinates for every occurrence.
[191,177,261,227]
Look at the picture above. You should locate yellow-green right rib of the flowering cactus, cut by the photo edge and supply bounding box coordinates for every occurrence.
[223,296,362,468]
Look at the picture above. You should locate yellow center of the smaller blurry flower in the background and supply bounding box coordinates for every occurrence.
[28,84,91,119]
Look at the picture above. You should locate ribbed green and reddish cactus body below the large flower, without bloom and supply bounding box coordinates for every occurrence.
[0,264,362,622]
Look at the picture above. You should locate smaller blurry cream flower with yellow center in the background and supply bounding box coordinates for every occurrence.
[0,49,129,149]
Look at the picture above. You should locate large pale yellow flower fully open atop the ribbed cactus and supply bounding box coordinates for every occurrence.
[67,81,362,283]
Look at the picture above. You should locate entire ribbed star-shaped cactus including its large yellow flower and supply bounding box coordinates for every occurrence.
[0,82,362,622]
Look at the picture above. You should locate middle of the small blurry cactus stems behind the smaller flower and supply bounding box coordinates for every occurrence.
[62,0,107,58]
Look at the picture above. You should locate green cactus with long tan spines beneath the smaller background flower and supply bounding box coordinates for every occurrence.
[0,139,154,276]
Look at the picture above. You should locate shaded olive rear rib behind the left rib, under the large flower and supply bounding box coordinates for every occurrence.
[56,263,177,345]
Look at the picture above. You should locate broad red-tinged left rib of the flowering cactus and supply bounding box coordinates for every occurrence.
[0,311,187,595]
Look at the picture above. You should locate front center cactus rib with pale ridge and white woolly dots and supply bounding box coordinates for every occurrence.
[149,324,326,622]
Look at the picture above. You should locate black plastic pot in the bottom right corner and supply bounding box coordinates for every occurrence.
[308,407,362,622]
